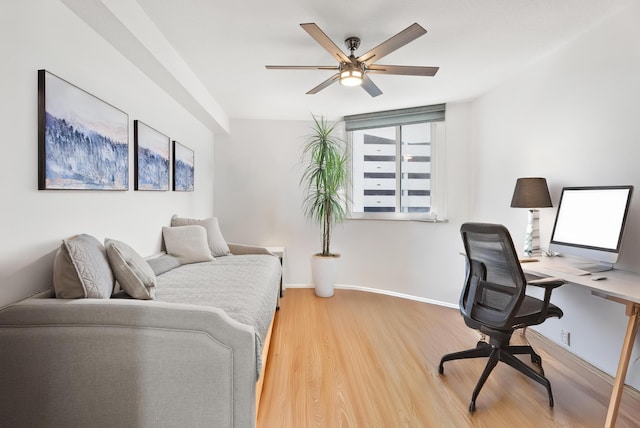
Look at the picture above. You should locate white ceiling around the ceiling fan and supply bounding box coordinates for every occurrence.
[137,0,631,119]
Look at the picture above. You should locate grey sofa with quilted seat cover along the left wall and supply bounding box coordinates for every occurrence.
[0,244,281,427]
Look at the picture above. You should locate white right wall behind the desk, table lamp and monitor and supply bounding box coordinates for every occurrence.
[471,1,640,388]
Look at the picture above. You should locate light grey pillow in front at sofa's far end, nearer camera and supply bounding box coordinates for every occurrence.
[162,225,214,265]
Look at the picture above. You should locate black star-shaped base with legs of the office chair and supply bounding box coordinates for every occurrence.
[438,335,553,413]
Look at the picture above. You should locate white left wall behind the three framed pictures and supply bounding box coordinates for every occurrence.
[0,0,214,307]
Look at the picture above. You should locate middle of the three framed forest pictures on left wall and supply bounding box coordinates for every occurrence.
[133,120,171,191]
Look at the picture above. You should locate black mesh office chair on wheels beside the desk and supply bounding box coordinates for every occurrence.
[438,223,564,413]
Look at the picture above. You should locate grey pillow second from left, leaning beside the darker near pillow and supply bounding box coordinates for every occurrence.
[104,239,156,300]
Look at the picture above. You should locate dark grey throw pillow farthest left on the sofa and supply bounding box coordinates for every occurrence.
[53,234,115,299]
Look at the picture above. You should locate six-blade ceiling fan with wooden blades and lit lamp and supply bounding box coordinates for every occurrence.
[265,23,439,97]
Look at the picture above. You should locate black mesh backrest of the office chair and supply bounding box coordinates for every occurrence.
[460,223,526,328]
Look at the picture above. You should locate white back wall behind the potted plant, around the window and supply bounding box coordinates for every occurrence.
[215,104,469,303]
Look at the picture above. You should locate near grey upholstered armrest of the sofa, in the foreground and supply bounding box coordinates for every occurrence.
[0,299,256,427]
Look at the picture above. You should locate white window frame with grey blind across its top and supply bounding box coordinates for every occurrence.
[344,104,447,222]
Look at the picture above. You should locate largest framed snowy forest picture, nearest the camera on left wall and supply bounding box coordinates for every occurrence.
[38,70,129,190]
